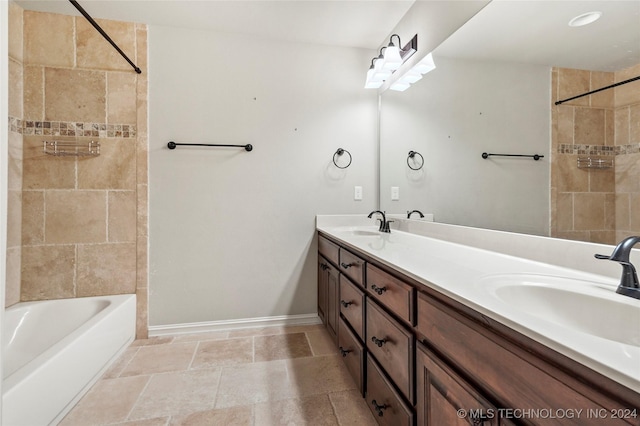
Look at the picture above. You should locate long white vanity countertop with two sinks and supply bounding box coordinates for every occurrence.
[317,221,640,393]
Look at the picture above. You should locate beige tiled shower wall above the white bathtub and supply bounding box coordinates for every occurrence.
[7,5,147,337]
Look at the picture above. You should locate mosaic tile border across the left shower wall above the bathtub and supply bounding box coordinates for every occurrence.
[9,117,136,138]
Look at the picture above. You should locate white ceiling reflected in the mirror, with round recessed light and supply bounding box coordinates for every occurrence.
[434,0,640,71]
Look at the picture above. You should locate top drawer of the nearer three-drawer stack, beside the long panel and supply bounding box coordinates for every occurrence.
[367,264,414,324]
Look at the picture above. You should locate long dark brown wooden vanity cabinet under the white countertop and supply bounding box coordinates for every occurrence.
[318,236,640,426]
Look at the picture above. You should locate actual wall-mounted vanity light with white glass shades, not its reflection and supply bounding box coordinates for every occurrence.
[364,34,418,89]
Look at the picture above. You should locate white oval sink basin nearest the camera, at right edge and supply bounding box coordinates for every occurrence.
[478,274,640,347]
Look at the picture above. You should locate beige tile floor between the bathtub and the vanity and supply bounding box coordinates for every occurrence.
[60,325,376,426]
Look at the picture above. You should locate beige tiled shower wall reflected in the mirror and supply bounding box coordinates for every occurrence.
[551,65,640,244]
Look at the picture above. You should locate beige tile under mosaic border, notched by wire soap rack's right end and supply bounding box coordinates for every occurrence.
[78,139,136,190]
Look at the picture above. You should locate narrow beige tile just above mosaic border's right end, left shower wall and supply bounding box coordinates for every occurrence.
[107,72,138,124]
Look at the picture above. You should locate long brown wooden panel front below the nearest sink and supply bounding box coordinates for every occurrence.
[416,293,628,425]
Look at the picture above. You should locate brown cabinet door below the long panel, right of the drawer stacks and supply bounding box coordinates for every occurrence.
[416,343,499,426]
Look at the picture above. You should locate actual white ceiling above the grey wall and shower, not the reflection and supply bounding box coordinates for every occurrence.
[16,0,414,49]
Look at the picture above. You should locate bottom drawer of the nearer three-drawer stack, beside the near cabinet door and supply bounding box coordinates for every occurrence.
[366,356,413,426]
